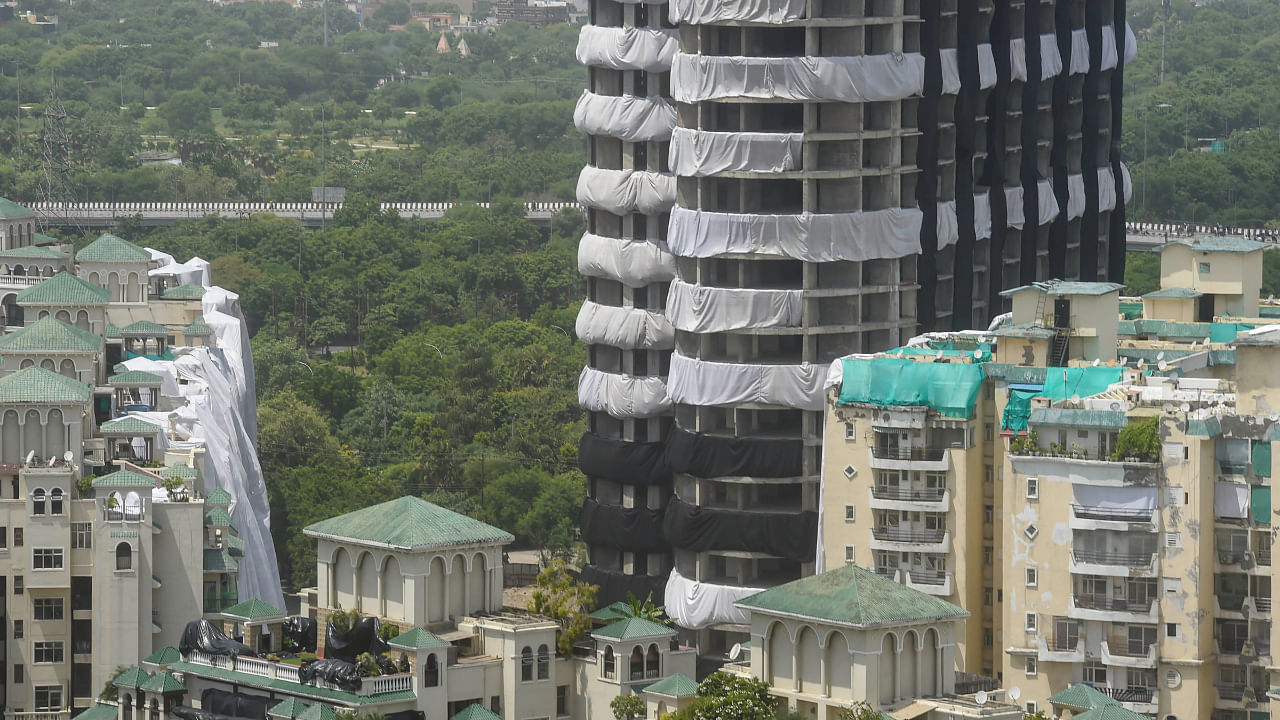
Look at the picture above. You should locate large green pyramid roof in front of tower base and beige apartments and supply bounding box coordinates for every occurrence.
[736,565,969,628]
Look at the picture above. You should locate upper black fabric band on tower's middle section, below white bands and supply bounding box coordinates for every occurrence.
[667,428,804,478]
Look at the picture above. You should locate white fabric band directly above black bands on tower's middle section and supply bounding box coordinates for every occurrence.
[667,352,827,410]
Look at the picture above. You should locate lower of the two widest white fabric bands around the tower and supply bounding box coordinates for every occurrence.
[667,208,924,263]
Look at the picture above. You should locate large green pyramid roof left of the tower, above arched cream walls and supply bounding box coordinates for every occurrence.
[302,496,516,550]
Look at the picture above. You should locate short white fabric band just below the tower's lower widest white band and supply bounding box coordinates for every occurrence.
[667,279,804,333]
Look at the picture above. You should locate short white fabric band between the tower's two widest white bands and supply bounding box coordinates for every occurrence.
[668,128,804,177]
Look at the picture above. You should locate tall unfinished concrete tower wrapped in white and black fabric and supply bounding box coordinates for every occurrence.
[575,0,1134,652]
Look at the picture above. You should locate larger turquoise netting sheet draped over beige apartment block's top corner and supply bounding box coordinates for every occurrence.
[840,357,984,418]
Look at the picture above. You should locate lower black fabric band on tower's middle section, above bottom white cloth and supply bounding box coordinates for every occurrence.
[663,497,818,562]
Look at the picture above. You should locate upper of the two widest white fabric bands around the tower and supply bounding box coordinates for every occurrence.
[671,53,931,102]
